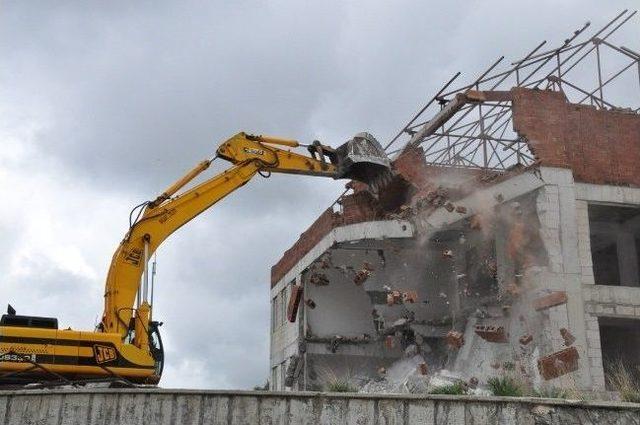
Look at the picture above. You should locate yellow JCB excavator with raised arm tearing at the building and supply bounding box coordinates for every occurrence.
[0,133,390,386]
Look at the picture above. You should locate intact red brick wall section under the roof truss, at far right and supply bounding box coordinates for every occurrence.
[512,88,640,187]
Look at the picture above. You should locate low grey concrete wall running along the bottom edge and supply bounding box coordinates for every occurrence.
[0,389,640,425]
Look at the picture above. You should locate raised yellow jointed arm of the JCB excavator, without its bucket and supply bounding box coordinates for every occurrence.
[100,133,388,349]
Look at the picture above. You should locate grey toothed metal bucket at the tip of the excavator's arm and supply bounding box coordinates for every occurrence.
[335,133,391,186]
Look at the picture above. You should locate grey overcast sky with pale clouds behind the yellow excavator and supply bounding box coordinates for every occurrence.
[0,0,638,388]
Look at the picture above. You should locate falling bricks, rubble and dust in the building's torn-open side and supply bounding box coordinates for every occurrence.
[291,147,579,393]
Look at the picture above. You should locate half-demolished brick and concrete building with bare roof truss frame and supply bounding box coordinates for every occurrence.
[270,11,640,391]
